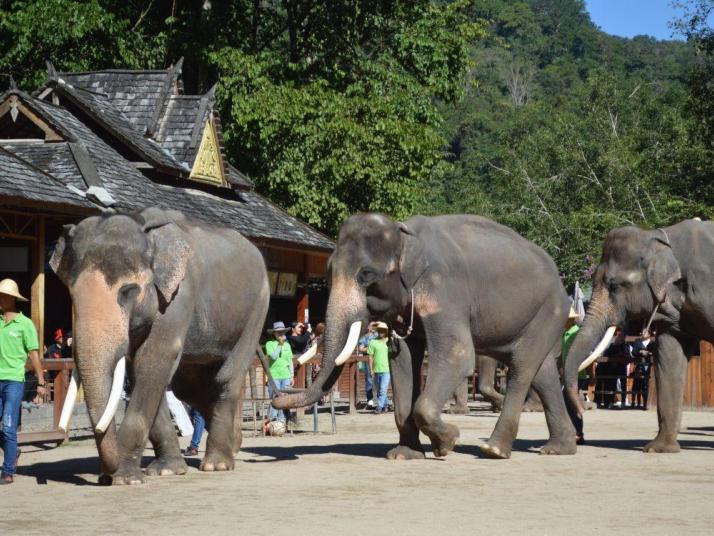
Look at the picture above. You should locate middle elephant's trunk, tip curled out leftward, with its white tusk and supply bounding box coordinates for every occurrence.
[273,278,367,409]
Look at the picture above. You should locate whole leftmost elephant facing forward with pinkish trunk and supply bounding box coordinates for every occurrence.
[50,209,270,484]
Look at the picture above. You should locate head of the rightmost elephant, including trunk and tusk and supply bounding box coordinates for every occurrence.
[565,227,682,408]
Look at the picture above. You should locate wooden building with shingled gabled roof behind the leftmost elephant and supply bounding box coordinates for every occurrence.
[0,61,334,343]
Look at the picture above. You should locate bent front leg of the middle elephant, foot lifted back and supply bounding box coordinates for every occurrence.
[414,319,476,456]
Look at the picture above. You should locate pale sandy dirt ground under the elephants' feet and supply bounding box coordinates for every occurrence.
[5,410,714,536]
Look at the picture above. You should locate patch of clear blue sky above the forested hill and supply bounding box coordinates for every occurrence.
[585,0,682,39]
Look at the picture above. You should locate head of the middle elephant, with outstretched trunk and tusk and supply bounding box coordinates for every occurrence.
[273,214,428,408]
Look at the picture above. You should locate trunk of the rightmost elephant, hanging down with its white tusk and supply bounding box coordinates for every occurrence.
[563,288,617,414]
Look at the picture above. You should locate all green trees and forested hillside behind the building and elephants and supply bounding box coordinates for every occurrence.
[0,0,714,283]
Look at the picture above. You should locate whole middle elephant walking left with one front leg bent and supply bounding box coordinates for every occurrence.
[273,214,576,459]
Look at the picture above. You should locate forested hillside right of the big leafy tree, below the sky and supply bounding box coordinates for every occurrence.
[431,0,714,282]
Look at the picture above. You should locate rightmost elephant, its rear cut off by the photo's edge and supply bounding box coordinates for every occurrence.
[565,220,714,452]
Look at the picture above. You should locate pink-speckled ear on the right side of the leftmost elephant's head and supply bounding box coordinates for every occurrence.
[142,212,193,303]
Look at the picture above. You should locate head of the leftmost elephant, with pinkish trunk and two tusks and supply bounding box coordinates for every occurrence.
[50,209,191,474]
